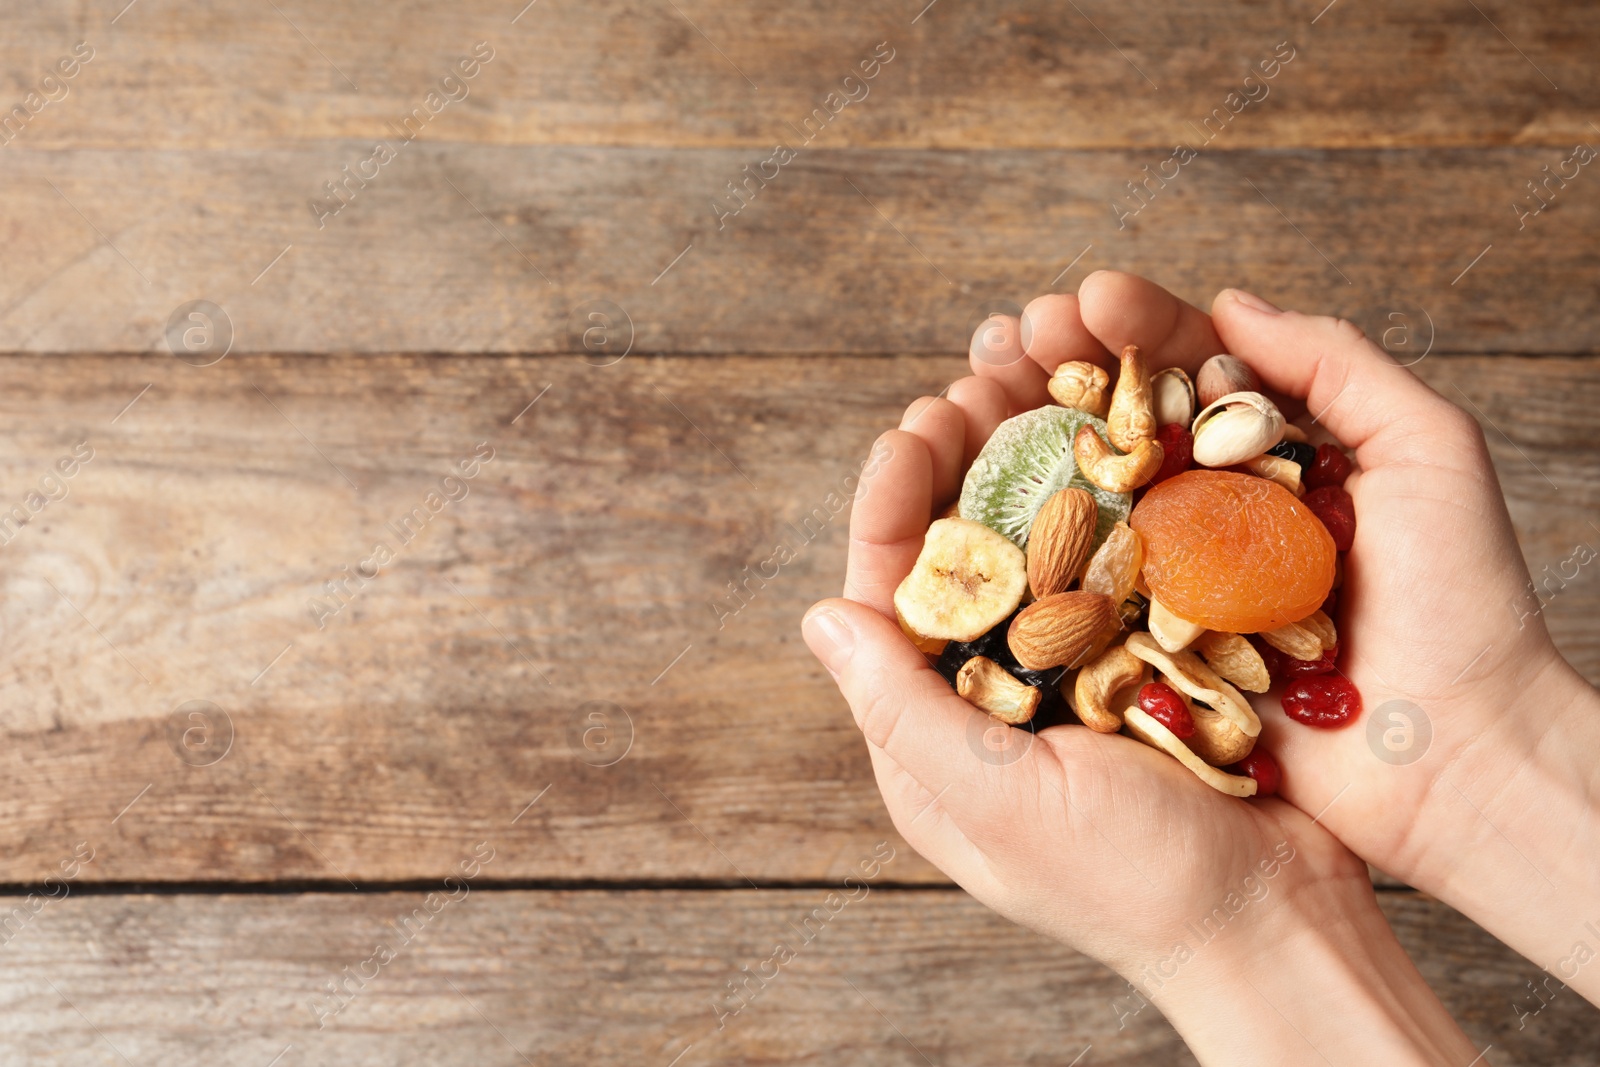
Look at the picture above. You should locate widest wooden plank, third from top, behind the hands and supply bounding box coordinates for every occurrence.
[0,355,1600,885]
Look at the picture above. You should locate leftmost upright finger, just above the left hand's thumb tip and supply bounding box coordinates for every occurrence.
[845,430,933,619]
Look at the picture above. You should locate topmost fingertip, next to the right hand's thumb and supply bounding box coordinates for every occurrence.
[1078,270,1226,374]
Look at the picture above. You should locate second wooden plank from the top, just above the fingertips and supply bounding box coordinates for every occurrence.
[0,141,1600,354]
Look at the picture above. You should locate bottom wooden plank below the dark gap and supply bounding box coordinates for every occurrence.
[0,886,1600,1067]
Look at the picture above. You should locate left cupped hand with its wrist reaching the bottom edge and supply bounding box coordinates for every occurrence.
[805,273,1477,1064]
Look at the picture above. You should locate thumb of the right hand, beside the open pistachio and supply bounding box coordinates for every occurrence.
[1211,290,1466,467]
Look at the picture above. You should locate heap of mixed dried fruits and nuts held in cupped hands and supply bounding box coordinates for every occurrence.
[894,346,1362,797]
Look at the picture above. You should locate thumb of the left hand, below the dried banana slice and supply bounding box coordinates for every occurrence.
[802,600,1038,796]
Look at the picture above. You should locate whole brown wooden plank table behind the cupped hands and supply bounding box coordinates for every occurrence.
[0,0,1600,1067]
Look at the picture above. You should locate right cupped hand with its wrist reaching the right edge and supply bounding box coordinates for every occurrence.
[971,272,1600,1003]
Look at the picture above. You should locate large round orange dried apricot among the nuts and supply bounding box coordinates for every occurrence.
[1128,470,1338,633]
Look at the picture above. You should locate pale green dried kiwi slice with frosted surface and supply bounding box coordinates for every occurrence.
[960,406,1133,549]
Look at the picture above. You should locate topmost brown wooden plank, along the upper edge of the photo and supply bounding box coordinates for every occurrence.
[0,0,1600,149]
